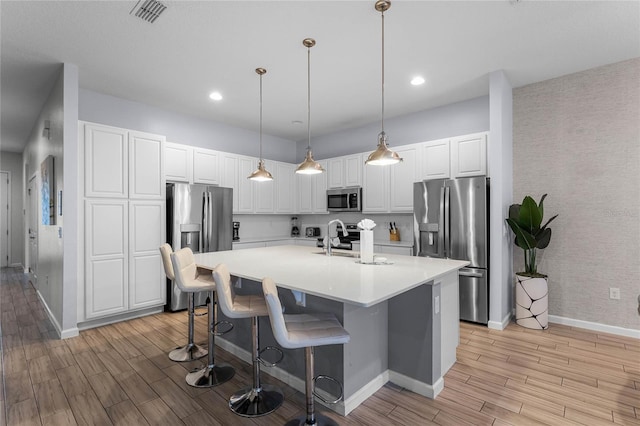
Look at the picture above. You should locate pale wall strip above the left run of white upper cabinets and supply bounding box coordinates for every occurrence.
[78,89,296,163]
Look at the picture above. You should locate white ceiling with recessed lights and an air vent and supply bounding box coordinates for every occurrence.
[0,0,640,151]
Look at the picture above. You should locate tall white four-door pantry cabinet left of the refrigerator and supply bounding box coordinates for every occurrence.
[78,122,166,322]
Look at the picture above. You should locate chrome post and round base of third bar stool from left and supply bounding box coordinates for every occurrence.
[229,317,284,417]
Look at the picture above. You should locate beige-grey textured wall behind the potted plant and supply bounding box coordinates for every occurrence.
[513,58,640,330]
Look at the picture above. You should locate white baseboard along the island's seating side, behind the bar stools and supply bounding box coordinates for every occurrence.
[216,338,389,416]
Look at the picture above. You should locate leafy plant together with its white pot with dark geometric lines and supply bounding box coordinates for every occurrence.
[506,194,558,330]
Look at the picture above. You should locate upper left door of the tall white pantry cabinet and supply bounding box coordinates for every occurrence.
[84,123,129,198]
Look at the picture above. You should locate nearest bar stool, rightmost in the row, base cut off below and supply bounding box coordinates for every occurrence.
[262,278,350,426]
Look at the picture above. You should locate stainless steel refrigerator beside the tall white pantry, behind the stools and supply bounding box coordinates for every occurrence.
[166,183,233,311]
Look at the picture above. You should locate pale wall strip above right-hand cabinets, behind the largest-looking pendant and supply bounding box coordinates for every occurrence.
[297,96,489,162]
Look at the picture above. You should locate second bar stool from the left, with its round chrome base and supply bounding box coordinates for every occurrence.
[171,247,235,388]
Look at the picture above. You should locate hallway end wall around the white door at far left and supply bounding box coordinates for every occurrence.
[0,152,25,266]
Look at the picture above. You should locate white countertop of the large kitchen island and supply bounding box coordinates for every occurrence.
[195,245,469,307]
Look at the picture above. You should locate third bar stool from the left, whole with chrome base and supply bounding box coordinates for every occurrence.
[213,263,284,417]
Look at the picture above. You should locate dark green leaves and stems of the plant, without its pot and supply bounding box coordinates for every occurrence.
[506,194,558,277]
